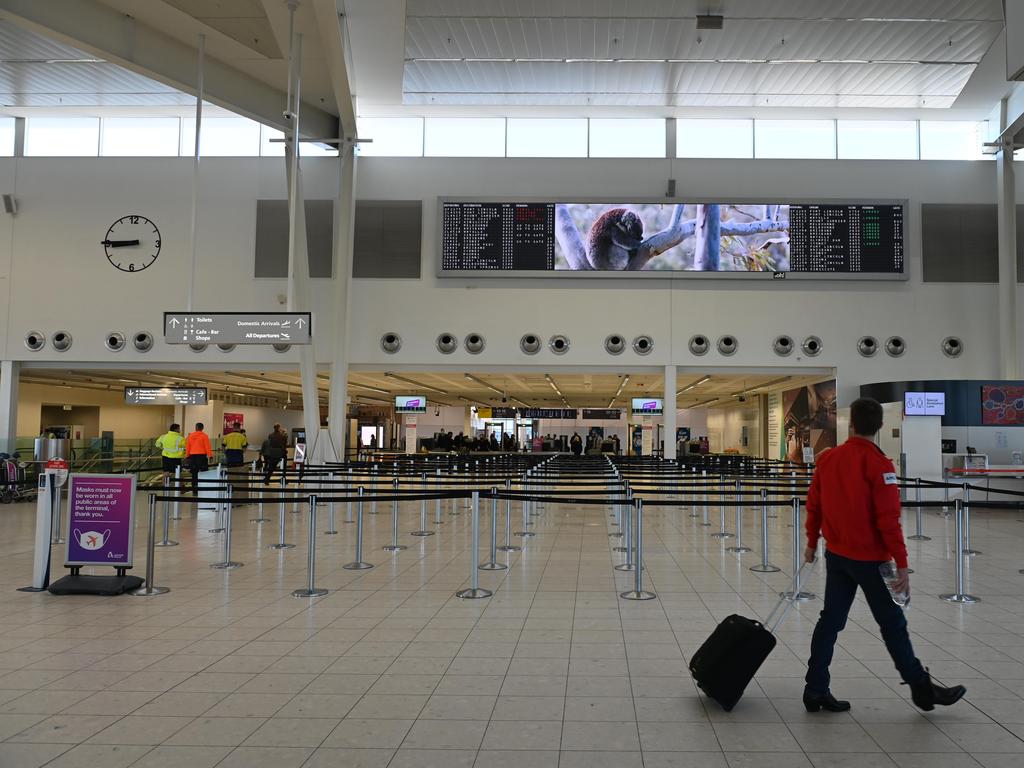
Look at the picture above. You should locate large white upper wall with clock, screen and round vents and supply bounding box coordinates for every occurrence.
[0,158,1024,417]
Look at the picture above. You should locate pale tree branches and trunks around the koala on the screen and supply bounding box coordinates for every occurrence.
[555,203,788,271]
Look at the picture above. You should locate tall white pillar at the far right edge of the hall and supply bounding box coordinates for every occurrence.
[995,98,1021,379]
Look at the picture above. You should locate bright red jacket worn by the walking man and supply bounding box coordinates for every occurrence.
[807,437,906,568]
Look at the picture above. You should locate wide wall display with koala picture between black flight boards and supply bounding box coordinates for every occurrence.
[438,200,904,279]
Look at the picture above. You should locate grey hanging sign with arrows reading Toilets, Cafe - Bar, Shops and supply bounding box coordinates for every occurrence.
[164,312,312,344]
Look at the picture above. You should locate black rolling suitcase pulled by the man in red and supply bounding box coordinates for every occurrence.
[690,568,804,712]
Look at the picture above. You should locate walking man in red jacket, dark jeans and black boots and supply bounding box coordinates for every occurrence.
[804,397,967,712]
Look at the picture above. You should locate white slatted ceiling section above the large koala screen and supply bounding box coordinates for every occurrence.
[402,0,1002,110]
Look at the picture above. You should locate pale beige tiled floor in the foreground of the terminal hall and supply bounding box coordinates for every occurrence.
[0,487,1024,768]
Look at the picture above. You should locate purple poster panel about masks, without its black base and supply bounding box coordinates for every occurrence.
[65,474,135,567]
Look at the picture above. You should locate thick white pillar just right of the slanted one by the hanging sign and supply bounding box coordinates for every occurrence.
[328,137,356,458]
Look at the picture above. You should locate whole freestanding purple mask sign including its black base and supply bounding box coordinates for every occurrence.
[46,473,142,595]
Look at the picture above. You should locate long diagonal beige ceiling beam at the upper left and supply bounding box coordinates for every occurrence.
[0,0,338,137]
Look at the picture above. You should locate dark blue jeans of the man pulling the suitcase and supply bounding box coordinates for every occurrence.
[805,552,928,695]
